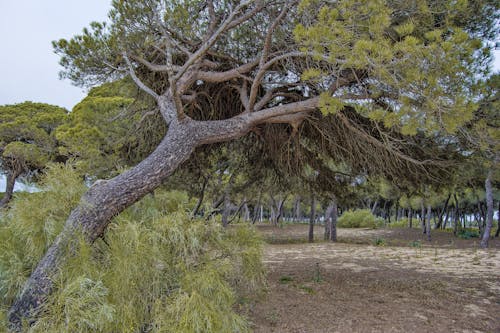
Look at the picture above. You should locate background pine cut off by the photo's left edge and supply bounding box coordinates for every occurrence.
[0,102,67,207]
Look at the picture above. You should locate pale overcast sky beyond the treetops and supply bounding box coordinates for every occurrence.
[0,0,500,110]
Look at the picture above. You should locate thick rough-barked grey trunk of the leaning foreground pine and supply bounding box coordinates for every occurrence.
[9,118,251,331]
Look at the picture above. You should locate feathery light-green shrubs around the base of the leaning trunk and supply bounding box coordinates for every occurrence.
[0,167,264,333]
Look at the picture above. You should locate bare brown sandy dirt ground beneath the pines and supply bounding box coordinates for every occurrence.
[247,225,500,333]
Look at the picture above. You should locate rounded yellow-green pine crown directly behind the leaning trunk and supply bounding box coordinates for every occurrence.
[55,80,166,178]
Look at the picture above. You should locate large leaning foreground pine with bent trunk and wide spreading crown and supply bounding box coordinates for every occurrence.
[9,0,498,330]
